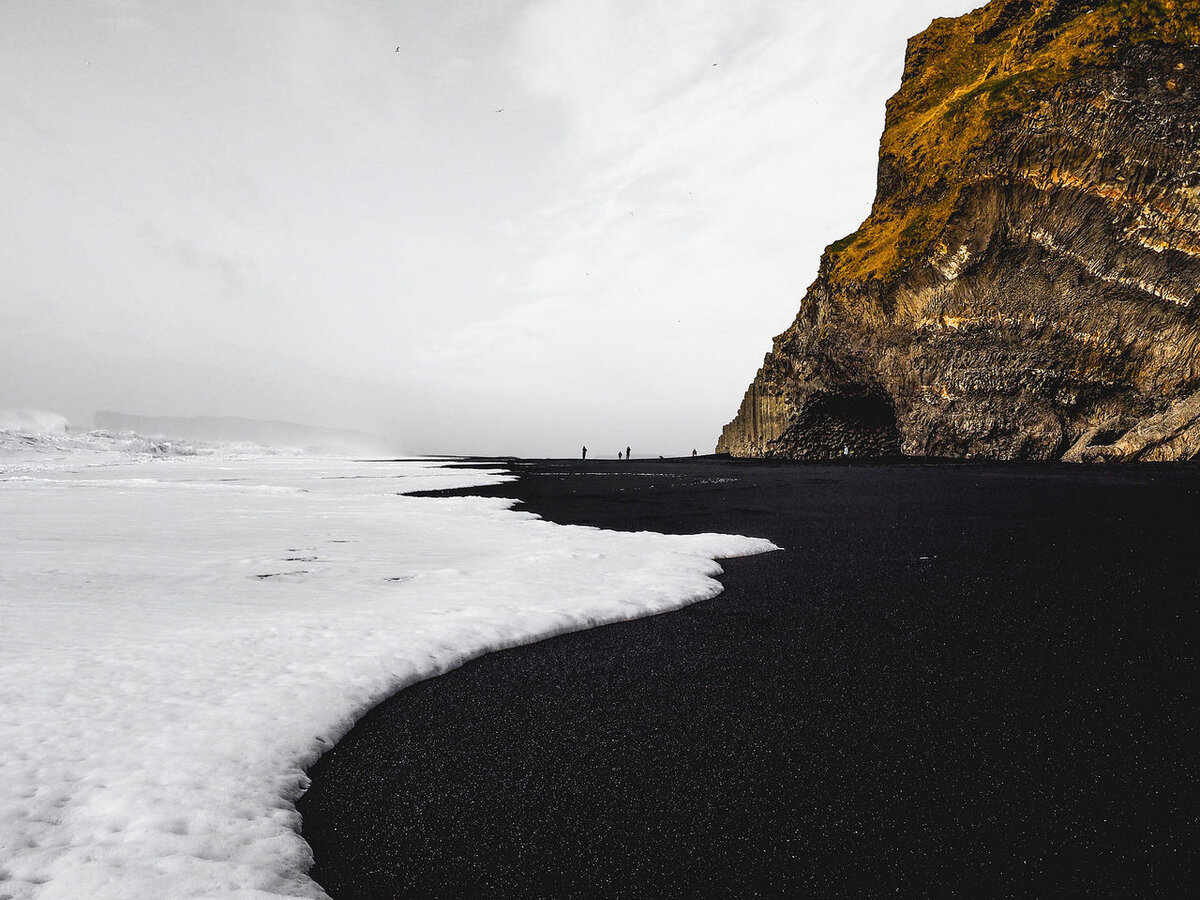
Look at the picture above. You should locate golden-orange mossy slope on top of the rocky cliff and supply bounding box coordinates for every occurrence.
[822,0,1200,287]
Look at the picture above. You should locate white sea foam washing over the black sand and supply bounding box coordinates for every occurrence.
[0,448,772,898]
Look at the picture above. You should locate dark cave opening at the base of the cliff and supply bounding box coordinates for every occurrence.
[778,392,900,458]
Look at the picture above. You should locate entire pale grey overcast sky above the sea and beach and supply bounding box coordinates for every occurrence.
[0,0,979,456]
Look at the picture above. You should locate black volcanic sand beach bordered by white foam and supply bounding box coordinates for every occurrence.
[299,457,1200,898]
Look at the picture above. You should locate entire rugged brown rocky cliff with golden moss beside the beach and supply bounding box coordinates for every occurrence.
[718,0,1200,460]
